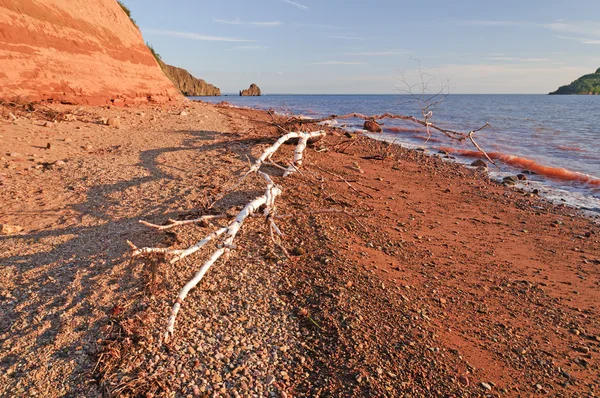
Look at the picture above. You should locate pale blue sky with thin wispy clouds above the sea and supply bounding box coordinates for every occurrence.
[123,0,600,94]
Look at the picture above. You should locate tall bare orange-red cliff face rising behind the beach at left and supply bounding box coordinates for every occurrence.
[0,0,181,105]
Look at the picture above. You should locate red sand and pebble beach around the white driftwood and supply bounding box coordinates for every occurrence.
[0,102,600,396]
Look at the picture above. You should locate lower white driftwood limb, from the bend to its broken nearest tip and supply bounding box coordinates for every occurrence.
[165,173,281,339]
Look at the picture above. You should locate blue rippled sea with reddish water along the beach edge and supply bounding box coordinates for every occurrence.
[190,94,600,215]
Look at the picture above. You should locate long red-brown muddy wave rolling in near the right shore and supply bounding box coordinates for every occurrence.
[440,147,600,186]
